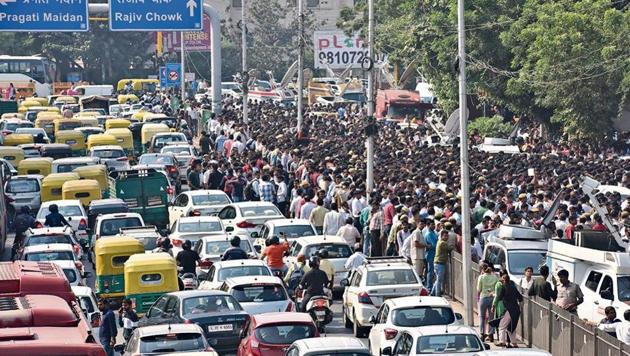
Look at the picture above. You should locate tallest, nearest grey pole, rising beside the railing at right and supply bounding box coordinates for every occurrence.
[457,0,474,326]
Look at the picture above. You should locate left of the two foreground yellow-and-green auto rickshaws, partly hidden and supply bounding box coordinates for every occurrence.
[94,236,144,302]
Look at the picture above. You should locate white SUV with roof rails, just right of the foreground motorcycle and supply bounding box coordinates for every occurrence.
[342,257,429,337]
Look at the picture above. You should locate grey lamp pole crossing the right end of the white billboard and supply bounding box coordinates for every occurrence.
[366,0,374,200]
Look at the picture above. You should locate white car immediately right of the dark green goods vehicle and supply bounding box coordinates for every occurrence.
[168,189,232,225]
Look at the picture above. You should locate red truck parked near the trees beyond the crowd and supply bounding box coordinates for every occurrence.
[375,89,433,121]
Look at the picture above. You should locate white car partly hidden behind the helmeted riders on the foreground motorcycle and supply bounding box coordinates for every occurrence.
[285,235,352,290]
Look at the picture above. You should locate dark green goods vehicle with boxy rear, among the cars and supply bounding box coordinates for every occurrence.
[109,168,174,228]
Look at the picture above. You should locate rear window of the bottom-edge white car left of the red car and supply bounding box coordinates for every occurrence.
[139,333,206,354]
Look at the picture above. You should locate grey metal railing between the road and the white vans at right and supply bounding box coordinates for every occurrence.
[444,252,630,356]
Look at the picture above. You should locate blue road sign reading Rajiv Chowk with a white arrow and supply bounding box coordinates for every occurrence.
[111,0,203,31]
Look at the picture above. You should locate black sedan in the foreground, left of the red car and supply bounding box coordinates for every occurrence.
[138,290,249,353]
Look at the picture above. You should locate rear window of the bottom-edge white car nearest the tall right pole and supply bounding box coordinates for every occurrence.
[416,334,483,355]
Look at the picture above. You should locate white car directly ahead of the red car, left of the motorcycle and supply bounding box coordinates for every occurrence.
[221,276,295,314]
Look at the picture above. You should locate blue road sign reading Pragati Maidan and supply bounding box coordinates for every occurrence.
[0,0,89,32]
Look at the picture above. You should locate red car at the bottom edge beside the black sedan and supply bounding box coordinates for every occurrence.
[237,312,319,356]
